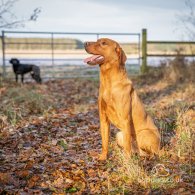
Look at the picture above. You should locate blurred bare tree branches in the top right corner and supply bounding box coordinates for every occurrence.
[178,0,195,40]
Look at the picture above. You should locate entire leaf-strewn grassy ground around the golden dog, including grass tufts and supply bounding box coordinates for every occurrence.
[0,68,195,194]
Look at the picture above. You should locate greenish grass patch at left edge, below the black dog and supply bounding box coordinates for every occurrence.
[0,86,54,125]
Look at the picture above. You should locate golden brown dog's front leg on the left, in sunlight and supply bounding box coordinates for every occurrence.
[99,98,110,160]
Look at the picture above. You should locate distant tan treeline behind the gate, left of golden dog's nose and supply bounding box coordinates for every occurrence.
[0,38,83,50]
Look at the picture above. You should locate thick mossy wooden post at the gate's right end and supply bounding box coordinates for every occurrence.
[141,28,148,74]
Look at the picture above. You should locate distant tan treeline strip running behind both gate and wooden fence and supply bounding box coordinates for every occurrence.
[0,37,195,54]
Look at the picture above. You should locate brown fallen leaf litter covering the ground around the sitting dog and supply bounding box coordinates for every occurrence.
[0,79,194,194]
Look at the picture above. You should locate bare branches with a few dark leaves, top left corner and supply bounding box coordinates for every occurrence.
[0,0,41,29]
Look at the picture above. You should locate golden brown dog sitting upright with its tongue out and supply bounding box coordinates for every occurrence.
[84,38,160,160]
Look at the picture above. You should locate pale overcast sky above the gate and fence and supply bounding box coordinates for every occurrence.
[7,0,194,40]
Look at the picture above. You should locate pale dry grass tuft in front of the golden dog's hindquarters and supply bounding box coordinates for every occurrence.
[108,145,177,194]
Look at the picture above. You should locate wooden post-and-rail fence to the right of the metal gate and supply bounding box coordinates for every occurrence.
[141,29,195,73]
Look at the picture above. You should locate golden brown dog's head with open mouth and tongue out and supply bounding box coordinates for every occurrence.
[84,38,127,66]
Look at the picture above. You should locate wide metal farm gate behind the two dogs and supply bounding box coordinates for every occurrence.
[0,31,141,79]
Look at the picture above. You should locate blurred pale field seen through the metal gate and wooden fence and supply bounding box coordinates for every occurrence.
[0,31,195,80]
